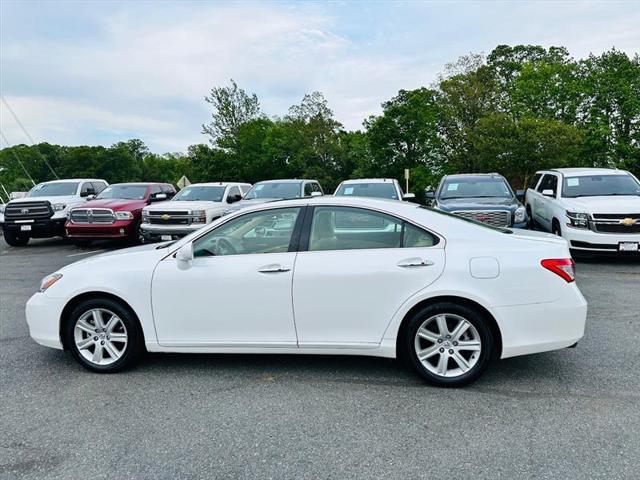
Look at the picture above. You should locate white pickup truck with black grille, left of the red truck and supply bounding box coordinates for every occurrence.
[2,178,109,247]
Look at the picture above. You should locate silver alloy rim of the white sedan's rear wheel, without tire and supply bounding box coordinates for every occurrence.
[414,313,482,378]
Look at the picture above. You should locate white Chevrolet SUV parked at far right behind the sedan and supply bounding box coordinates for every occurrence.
[525,168,640,253]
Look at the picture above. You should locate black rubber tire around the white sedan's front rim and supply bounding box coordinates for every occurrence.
[62,298,144,373]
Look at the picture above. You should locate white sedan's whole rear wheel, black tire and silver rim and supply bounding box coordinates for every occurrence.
[404,302,494,387]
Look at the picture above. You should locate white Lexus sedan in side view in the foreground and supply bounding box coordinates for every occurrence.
[27,197,587,386]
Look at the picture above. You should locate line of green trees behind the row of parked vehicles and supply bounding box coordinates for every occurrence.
[0,45,640,199]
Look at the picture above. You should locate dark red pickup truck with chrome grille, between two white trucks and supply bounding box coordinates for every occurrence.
[65,183,176,246]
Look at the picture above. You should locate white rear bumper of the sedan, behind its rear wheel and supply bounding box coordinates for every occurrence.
[494,284,587,358]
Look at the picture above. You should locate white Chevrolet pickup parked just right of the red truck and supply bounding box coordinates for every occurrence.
[140,182,251,242]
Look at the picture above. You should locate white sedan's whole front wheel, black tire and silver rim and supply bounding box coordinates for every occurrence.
[63,298,143,373]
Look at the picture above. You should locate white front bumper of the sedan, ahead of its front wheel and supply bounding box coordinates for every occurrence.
[25,292,64,349]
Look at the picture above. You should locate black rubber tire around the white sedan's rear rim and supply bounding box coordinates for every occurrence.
[401,302,495,387]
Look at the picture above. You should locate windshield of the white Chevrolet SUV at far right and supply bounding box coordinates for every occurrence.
[562,175,640,198]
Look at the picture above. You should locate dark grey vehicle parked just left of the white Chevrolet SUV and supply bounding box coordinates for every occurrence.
[427,173,529,228]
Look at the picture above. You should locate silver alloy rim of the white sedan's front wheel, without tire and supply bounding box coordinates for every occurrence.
[73,308,129,365]
